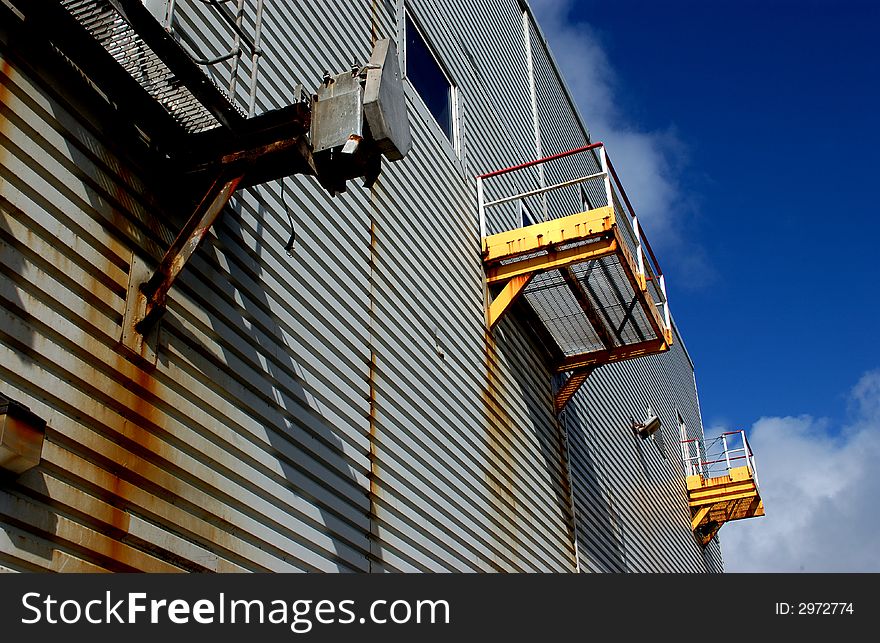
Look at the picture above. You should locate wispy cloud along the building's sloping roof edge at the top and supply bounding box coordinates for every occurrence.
[530,0,714,288]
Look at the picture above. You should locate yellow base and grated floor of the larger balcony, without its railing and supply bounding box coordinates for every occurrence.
[483,206,672,411]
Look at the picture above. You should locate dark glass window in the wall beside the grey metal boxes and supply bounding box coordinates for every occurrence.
[404,14,454,142]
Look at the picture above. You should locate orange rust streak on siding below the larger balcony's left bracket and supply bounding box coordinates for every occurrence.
[482,331,518,571]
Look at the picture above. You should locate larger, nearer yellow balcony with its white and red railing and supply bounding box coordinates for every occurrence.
[478,143,672,412]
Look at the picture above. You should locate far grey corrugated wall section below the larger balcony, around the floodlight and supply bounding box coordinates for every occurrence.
[567,341,711,572]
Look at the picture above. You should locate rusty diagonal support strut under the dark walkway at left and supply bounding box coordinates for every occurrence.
[134,169,245,335]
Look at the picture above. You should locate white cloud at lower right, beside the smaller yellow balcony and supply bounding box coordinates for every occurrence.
[719,370,880,572]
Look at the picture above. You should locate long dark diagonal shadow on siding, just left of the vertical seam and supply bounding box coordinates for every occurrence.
[194,189,370,571]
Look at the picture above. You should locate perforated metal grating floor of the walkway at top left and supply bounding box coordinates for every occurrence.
[61,0,244,134]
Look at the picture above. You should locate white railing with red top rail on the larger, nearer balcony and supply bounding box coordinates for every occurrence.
[476,141,672,330]
